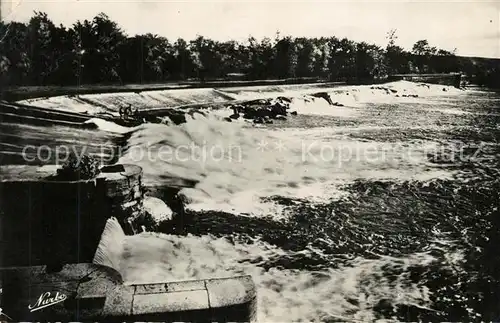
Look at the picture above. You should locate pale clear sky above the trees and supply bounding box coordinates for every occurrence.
[0,0,500,58]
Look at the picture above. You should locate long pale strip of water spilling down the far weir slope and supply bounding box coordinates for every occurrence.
[15,81,467,115]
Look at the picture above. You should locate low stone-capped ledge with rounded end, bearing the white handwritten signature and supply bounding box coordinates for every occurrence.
[0,264,256,322]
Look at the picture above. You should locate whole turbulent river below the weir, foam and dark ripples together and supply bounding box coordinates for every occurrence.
[89,82,500,322]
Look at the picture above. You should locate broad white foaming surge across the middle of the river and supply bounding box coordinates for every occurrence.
[119,109,458,220]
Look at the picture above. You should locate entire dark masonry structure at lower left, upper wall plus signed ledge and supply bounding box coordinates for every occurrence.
[0,165,256,322]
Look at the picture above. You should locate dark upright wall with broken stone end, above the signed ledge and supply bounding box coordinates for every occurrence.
[0,165,144,266]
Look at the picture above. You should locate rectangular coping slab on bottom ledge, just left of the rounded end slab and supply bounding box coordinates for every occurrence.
[132,290,209,315]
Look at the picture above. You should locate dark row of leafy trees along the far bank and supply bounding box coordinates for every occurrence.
[0,12,498,86]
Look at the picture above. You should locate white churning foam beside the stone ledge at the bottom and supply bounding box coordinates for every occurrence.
[115,233,456,322]
